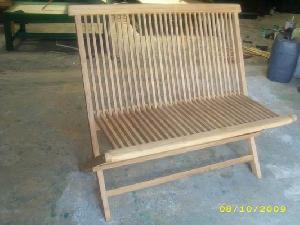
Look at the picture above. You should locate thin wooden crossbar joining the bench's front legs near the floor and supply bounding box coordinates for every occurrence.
[107,155,253,197]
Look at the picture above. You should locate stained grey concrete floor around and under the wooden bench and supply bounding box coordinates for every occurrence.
[0,15,300,225]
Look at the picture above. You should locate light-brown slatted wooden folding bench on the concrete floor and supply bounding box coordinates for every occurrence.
[69,4,296,220]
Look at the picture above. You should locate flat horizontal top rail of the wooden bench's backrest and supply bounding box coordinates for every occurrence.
[69,3,241,16]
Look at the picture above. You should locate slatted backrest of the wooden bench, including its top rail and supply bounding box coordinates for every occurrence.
[69,4,246,113]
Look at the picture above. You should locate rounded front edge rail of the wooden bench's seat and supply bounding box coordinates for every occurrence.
[105,115,297,162]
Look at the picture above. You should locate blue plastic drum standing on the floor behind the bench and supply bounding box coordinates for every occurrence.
[268,38,300,83]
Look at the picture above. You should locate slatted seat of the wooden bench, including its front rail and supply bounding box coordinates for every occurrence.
[96,95,295,162]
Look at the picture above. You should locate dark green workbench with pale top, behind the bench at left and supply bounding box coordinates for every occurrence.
[3,0,110,51]
